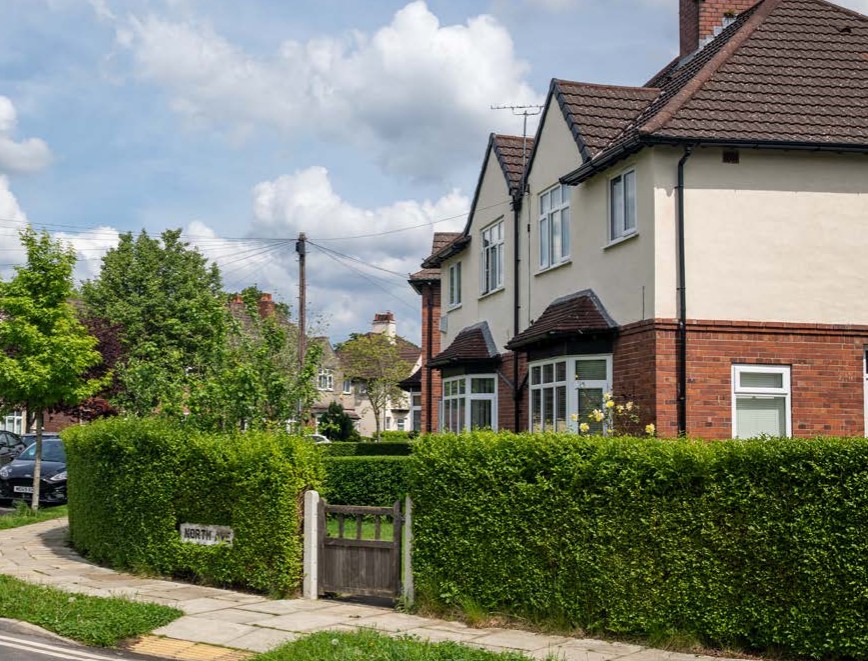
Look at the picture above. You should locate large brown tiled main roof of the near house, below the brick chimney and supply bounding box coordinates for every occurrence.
[543,0,868,184]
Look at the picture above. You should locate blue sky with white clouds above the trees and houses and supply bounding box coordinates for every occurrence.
[0,0,868,340]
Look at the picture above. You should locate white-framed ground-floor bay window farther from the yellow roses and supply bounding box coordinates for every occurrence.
[440,374,497,432]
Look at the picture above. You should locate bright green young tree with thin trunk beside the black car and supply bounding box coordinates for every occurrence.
[0,228,105,510]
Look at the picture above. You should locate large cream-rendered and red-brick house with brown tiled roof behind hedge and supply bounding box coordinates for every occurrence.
[411,0,868,438]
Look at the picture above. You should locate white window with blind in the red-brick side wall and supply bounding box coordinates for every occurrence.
[732,365,792,438]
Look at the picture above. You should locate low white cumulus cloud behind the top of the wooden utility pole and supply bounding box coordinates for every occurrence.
[185,166,474,339]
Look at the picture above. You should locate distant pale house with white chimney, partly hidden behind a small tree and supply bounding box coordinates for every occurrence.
[313,312,422,436]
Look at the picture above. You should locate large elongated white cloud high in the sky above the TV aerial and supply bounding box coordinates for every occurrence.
[117,0,542,179]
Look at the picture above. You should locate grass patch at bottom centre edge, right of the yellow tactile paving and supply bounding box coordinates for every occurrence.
[254,631,554,661]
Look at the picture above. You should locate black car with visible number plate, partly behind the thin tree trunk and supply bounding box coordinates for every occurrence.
[0,435,66,504]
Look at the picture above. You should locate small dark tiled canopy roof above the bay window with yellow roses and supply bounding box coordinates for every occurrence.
[506,289,618,350]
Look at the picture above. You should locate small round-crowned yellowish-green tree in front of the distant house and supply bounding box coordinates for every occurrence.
[339,333,411,440]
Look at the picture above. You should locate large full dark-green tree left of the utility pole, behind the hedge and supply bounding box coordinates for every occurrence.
[82,230,226,415]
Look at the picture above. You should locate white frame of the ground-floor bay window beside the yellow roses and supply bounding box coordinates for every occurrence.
[527,354,612,434]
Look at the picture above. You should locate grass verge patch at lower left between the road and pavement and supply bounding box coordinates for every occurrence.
[0,576,183,647]
